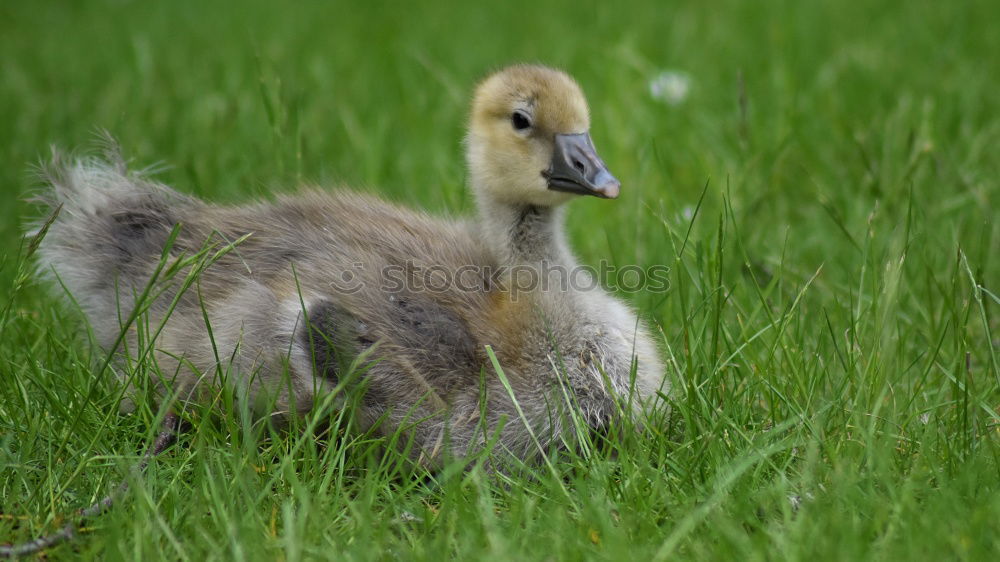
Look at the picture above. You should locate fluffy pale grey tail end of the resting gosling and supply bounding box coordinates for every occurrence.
[33,140,194,339]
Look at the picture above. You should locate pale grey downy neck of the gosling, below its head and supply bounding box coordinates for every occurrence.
[478,197,573,265]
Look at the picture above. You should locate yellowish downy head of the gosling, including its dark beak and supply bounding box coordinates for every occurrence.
[467,65,621,207]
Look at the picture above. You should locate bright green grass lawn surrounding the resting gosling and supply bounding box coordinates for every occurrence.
[0,0,1000,561]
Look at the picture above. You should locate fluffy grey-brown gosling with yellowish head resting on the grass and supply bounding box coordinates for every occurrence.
[39,65,667,467]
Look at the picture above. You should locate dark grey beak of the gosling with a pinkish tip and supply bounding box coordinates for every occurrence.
[542,133,621,199]
